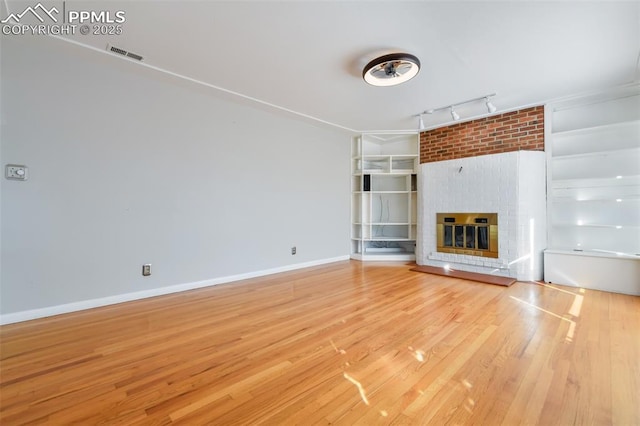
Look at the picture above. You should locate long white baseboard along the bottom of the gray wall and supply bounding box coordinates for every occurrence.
[0,255,349,325]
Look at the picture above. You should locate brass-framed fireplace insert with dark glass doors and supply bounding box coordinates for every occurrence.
[436,213,498,258]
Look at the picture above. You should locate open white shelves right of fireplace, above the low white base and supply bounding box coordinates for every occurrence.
[546,89,640,260]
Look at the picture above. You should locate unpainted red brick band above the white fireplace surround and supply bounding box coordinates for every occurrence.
[420,106,544,163]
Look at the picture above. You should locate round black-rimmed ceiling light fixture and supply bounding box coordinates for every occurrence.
[362,53,420,86]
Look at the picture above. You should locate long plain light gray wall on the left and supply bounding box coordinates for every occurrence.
[0,37,350,314]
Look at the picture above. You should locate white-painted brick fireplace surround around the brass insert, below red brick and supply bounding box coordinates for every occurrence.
[416,151,546,281]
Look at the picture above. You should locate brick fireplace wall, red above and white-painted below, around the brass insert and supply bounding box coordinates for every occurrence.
[416,107,546,281]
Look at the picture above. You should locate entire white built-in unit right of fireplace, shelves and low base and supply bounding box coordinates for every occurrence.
[545,86,640,294]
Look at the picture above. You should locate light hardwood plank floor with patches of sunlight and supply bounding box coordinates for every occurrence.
[0,261,640,426]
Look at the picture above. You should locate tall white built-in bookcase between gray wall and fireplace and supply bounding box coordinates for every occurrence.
[351,134,419,260]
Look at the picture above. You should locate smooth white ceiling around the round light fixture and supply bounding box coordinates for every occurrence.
[3,0,640,131]
